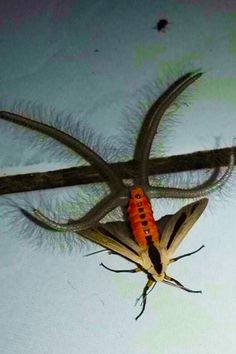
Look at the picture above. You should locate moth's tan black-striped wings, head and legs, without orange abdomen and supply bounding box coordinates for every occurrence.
[80,198,208,320]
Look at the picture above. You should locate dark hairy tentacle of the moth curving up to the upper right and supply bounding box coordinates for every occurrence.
[134,72,202,189]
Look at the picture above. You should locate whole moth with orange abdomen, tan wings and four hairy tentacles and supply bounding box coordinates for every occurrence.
[0,72,234,319]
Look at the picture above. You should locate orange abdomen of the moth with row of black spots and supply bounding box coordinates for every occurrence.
[128,187,159,247]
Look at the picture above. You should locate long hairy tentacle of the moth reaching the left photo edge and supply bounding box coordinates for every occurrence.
[0,111,124,191]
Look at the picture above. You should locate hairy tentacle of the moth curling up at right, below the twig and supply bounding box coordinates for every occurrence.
[148,143,235,198]
